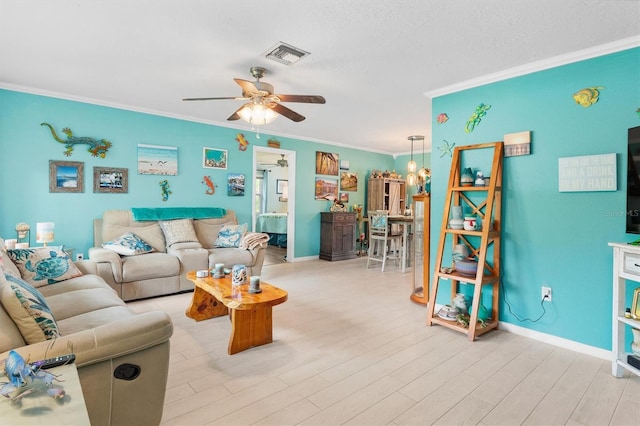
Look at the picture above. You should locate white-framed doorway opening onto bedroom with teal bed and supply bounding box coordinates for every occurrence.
[252,146,296,262]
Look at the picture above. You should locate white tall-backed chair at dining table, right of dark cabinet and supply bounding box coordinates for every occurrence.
[367,210,402,272]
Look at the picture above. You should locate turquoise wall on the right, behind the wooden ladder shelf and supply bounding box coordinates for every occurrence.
[431,48,640,349]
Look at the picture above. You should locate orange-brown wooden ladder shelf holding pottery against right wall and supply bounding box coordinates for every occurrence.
[427,142,504,341]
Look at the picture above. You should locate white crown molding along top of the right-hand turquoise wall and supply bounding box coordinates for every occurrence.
[424,36,640,98]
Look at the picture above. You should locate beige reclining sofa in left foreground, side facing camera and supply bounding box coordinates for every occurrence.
[0,245,173,426]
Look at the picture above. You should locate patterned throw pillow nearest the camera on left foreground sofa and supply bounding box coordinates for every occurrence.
[0,273,60,344]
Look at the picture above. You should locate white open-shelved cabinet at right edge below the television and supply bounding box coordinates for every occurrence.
[609,243,640,377]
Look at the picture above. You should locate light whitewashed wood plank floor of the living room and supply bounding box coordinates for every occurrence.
[129,257,640,425]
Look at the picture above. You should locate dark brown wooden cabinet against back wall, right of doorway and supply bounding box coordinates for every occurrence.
[319,212,358,260]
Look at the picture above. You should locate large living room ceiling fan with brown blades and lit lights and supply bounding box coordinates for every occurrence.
[183,67,326,125]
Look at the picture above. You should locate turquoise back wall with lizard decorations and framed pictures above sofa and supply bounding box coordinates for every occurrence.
[0,90,394,257]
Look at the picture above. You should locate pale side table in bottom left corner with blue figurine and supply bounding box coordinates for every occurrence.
[0,364,91,426]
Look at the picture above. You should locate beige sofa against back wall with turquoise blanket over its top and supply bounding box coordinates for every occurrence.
[89,208,268,301]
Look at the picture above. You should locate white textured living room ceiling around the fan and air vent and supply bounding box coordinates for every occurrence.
[0,0,640,154]
